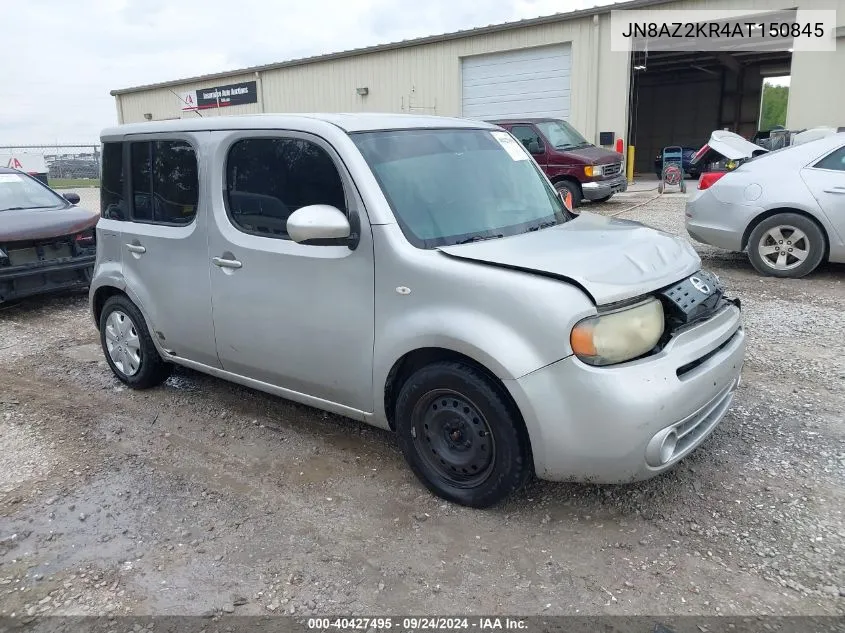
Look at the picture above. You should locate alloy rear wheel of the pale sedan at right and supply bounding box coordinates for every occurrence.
[748,213,826,279]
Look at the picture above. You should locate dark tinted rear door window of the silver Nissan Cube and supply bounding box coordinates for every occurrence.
[129,141,199,225]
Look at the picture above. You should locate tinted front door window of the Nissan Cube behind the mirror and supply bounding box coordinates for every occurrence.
[226,138,346,239]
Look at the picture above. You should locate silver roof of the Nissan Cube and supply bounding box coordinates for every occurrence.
[101,112,494,137]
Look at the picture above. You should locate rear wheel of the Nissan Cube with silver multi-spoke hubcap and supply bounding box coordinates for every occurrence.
[100,295,173,389]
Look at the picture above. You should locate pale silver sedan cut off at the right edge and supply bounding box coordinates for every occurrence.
[686,132,845,277]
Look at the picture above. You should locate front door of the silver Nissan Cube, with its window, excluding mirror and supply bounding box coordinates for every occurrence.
[208,133,374,412]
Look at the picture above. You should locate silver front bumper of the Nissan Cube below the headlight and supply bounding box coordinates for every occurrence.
[508,305,745,483]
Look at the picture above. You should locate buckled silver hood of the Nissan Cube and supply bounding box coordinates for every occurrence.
[439,212,701,305]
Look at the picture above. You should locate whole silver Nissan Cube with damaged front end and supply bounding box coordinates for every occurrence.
[90,114,745,507]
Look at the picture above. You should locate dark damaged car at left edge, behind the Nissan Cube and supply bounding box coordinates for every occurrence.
[0,167,99,303]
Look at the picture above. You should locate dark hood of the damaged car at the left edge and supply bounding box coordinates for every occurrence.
[0,207,99,242]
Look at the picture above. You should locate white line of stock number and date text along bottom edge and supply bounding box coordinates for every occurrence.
[307,616,527,631]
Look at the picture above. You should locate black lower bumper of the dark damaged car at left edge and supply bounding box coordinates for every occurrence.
[0,255,96,302]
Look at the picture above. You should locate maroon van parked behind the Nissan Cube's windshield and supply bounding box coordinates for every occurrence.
[490,118,628,207]
